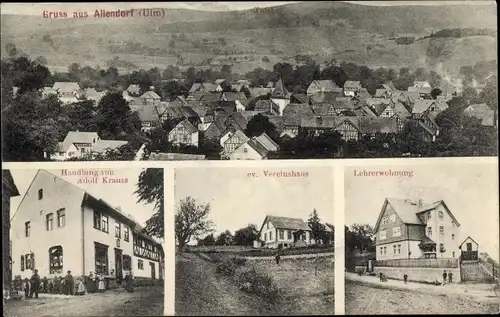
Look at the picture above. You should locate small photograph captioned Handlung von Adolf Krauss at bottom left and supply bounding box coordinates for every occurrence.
[2,168,165,317]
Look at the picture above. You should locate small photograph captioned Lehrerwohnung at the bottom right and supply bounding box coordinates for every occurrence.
[345,159,500,315]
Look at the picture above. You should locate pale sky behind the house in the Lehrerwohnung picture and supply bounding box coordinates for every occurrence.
[345,161,500,261]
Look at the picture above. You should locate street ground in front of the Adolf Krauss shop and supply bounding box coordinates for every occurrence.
[4,286,164,317]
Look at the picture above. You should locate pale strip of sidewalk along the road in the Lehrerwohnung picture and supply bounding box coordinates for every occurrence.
[345,272,499,302]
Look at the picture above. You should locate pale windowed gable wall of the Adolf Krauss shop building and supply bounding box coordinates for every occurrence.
[11,170,84,278]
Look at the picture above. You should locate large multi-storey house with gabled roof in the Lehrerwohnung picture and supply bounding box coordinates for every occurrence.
[374,198,460,261]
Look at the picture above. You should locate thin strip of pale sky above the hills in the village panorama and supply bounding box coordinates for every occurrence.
[1,0,494,15]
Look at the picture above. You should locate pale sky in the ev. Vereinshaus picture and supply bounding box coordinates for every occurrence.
[175,167,334,243]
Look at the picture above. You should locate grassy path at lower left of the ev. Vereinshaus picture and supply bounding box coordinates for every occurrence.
[175,253,276,316]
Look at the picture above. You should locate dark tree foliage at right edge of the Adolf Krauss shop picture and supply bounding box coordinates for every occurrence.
[134,168,165,238]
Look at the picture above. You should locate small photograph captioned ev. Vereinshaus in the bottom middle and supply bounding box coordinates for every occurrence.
[175,167,335,316]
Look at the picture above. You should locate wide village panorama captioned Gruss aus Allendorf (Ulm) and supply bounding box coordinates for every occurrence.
[1,1,498,161]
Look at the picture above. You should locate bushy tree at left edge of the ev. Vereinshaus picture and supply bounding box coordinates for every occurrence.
[175,197,214,252]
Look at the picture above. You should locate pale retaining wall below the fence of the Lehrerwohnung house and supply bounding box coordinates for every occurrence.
[374,267,461,283]
